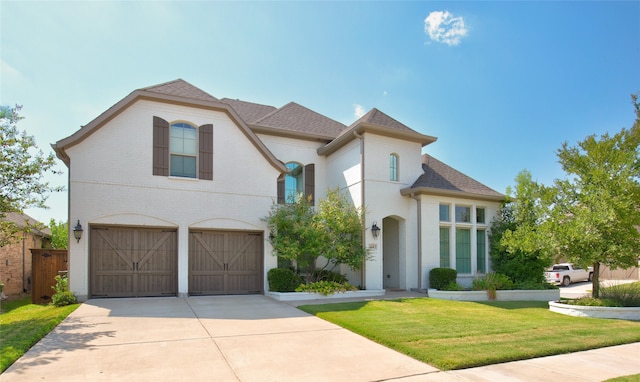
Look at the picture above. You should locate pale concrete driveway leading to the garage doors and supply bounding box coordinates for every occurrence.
[0,295,438,382]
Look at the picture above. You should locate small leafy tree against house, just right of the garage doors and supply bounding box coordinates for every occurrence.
[264,189,367,282]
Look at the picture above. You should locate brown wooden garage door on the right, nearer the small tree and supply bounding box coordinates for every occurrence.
[189,231,263,295]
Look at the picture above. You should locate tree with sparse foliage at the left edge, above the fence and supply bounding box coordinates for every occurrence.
[0,106,61,246]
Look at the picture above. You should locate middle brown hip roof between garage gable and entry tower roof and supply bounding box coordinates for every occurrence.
[255,102,347,138]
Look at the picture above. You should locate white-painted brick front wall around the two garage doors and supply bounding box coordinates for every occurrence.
[67,100,280,299]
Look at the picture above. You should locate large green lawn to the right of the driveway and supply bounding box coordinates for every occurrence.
[299,298,640,370]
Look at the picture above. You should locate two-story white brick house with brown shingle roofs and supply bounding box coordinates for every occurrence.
[52,79,504,300]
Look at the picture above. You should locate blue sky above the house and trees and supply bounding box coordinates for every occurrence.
[0,0,640,222]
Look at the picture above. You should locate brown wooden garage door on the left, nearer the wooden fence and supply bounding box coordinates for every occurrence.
[89,227,178,297]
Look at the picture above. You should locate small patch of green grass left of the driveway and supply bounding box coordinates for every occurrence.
[0,297,80,373]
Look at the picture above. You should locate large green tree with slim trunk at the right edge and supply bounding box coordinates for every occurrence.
[549,95,640,298]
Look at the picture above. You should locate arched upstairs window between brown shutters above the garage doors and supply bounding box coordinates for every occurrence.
[169,123,198,178]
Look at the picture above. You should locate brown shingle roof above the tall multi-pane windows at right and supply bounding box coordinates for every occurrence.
[403,154,505,200]
